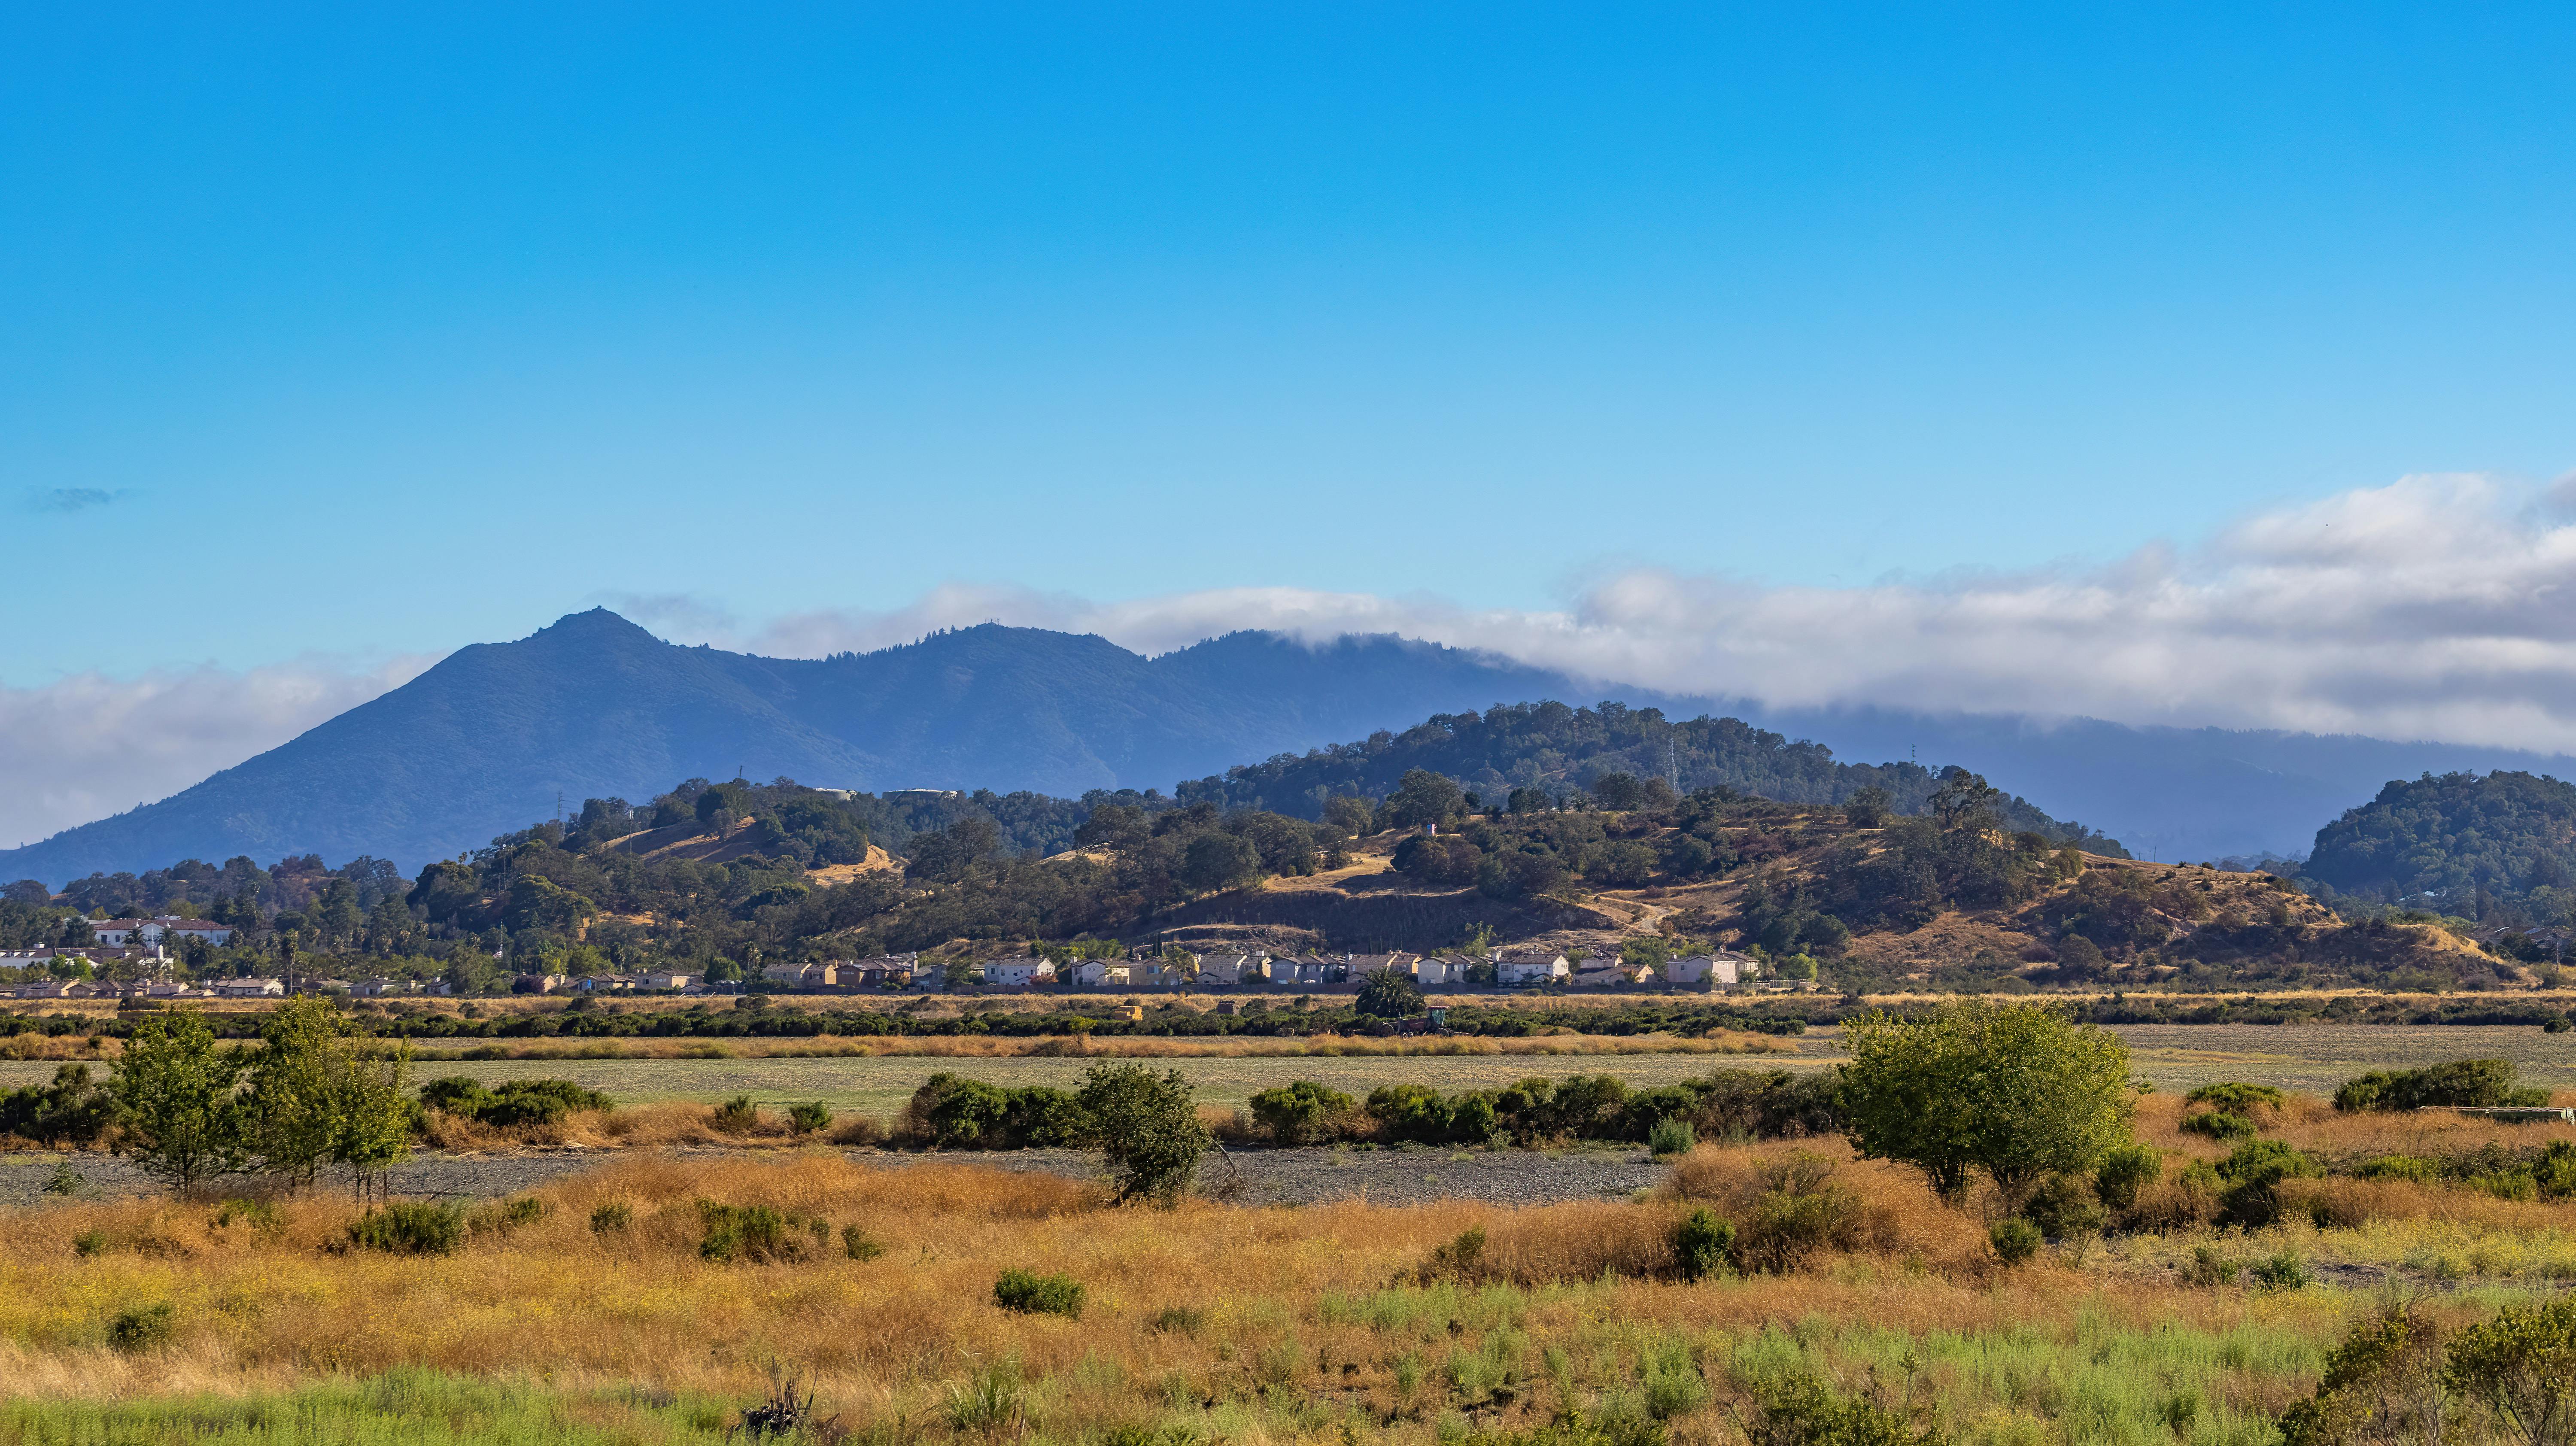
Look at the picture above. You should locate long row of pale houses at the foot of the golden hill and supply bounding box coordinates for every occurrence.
[762,948,1762,992]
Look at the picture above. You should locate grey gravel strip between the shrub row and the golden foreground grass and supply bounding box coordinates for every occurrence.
[0,1147,1664,1209]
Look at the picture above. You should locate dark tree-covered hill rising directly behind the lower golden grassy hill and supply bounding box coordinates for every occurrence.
[1180,701,2128,858]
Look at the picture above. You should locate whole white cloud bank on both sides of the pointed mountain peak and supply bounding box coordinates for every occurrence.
[0,474,2576,843]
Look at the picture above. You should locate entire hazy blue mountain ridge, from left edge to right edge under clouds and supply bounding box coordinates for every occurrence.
[0,608,2576,884]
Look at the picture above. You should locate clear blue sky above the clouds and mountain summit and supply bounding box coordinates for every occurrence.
[0,5,2576,688]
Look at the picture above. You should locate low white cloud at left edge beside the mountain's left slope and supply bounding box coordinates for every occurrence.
[0,657,435,848]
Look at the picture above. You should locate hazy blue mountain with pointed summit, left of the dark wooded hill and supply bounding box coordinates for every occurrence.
[0,611,1607,884]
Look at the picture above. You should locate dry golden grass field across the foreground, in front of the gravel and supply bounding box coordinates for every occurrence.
[0,1152,2339,1441]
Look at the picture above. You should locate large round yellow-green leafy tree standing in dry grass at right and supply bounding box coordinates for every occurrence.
[1842,1000,2136,1209]
